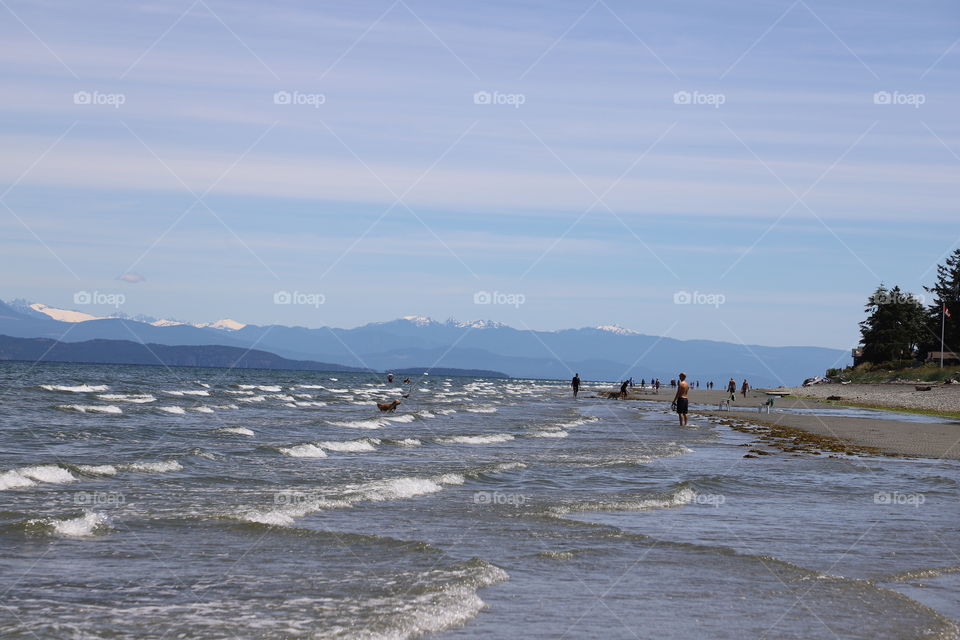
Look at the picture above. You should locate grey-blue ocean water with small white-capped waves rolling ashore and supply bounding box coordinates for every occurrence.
[0,363,960,640]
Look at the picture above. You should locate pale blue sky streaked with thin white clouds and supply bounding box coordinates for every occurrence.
[0,0,960,349]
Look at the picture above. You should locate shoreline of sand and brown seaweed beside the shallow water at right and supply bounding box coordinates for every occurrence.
[598,385,960,460]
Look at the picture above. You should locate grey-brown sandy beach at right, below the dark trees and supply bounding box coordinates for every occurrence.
[596,385,960,459]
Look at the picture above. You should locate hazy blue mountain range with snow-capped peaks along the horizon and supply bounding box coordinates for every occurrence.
[0,300,850,386]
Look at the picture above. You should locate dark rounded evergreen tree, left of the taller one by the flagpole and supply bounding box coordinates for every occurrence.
[860,284,926,366]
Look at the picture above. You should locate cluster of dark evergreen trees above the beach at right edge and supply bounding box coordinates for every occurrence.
[858,249,960,366]
